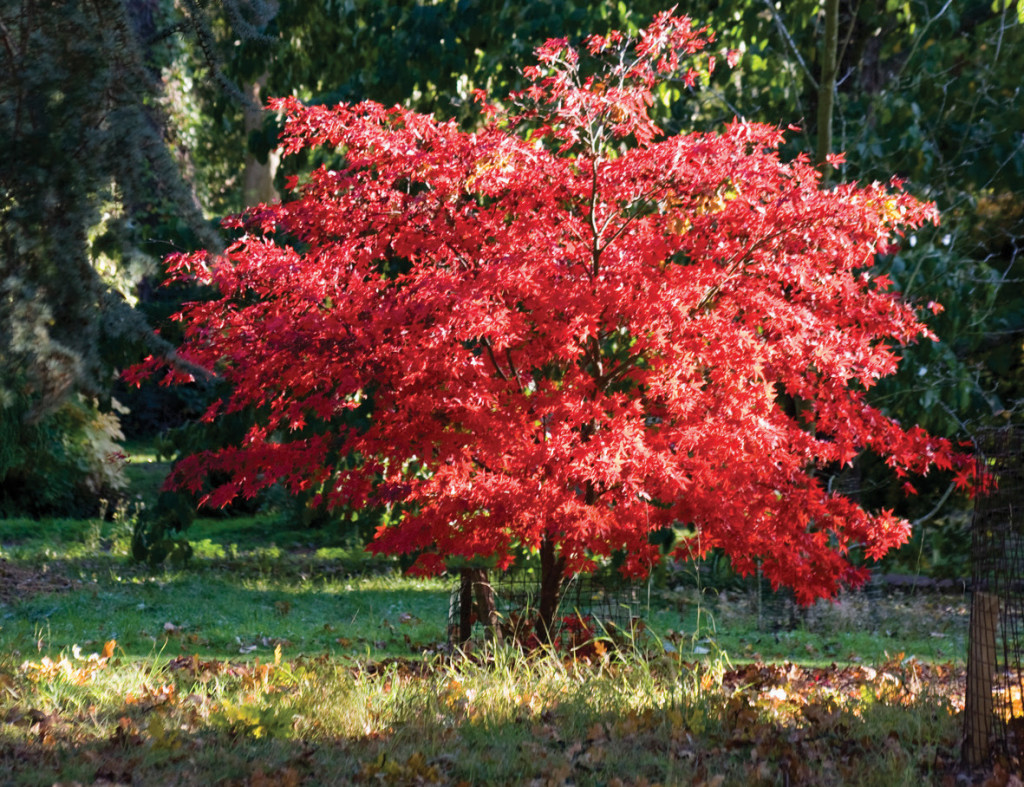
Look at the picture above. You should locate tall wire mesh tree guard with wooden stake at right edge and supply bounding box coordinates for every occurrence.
[964,427,1024,768]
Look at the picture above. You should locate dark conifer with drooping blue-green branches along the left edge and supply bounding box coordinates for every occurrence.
[0,0,276,515]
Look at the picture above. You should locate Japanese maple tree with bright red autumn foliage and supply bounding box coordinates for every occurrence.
[130,13,971,621]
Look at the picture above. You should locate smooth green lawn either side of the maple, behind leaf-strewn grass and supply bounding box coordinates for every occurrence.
[0,517,968,666]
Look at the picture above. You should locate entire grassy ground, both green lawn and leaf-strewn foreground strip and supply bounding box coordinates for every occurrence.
[0,452,967,787]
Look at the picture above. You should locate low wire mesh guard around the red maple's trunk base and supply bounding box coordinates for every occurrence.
[447,564,645,648]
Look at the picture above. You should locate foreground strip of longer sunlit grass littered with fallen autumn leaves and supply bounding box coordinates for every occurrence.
[0,645,964,785]
